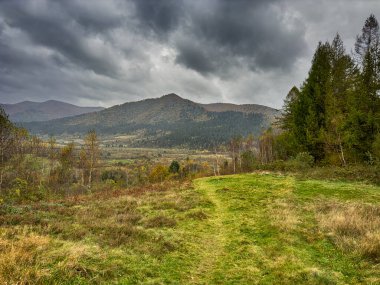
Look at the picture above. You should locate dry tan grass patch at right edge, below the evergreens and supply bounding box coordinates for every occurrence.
[318,202,380,261]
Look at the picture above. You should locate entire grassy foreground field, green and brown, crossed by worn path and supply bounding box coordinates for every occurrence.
[0,173,380,284]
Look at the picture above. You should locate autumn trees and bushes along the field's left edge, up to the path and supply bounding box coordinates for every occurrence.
[0,107,210,202]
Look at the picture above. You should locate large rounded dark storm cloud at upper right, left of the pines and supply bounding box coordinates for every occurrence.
[179,1,305,70]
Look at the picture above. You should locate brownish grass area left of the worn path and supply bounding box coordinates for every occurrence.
[0,182,205,285]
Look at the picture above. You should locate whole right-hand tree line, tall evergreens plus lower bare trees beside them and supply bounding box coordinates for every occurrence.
[218,15,380,174]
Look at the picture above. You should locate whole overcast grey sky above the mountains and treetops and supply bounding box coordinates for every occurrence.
[0,0,380,108]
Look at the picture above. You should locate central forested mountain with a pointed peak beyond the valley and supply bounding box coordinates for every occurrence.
[23,94,278,148]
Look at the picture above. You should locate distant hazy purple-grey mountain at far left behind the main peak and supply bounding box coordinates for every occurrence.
[0,100,104,122]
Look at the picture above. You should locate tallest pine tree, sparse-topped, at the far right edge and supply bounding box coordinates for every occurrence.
[349,15,380,158]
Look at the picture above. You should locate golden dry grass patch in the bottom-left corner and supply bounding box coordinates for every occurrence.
[0,227,107,285]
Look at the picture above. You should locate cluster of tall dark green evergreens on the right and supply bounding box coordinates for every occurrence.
[278,15,380,165]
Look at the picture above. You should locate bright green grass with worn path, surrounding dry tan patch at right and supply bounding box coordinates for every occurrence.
[191,175,380,284]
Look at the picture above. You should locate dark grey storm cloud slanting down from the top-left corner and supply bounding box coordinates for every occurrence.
[1,1,124,76]
